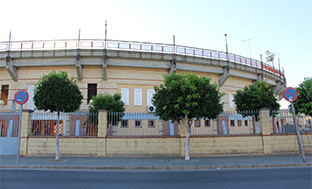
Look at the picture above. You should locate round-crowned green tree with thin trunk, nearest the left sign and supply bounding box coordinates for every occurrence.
[34,71,83,160]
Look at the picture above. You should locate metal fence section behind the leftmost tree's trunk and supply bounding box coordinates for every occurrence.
[32,112,98,137]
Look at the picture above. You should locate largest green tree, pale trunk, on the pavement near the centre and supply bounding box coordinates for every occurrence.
[152,73,223,160]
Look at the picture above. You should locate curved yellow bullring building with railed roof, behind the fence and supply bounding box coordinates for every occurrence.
[0,40,286,112]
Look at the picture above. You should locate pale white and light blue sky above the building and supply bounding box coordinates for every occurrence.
[0,0,312,108]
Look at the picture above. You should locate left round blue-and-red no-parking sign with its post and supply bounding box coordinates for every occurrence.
[14,90,29,165]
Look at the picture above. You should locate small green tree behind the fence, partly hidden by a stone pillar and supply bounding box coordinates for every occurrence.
[89,93,125,125]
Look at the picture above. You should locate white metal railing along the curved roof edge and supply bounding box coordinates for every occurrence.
[0,39,284,79]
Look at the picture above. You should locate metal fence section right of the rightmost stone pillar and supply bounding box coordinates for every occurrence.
[270,109,312,134]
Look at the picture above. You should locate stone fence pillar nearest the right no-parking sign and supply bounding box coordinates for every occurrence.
[259,108,272,154]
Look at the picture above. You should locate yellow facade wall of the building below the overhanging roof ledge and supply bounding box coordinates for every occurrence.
[0,66,258,112]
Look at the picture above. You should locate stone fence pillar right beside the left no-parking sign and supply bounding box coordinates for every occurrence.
[18,110,34,155]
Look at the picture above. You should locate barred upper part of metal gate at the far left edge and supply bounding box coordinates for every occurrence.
[0,112,19,137]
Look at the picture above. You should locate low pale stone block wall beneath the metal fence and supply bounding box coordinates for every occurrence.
[20,134,312,157]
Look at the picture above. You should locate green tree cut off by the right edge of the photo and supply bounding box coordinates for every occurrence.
[294,77,312,116]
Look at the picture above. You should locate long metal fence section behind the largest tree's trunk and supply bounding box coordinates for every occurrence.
[108,111,260,137]
